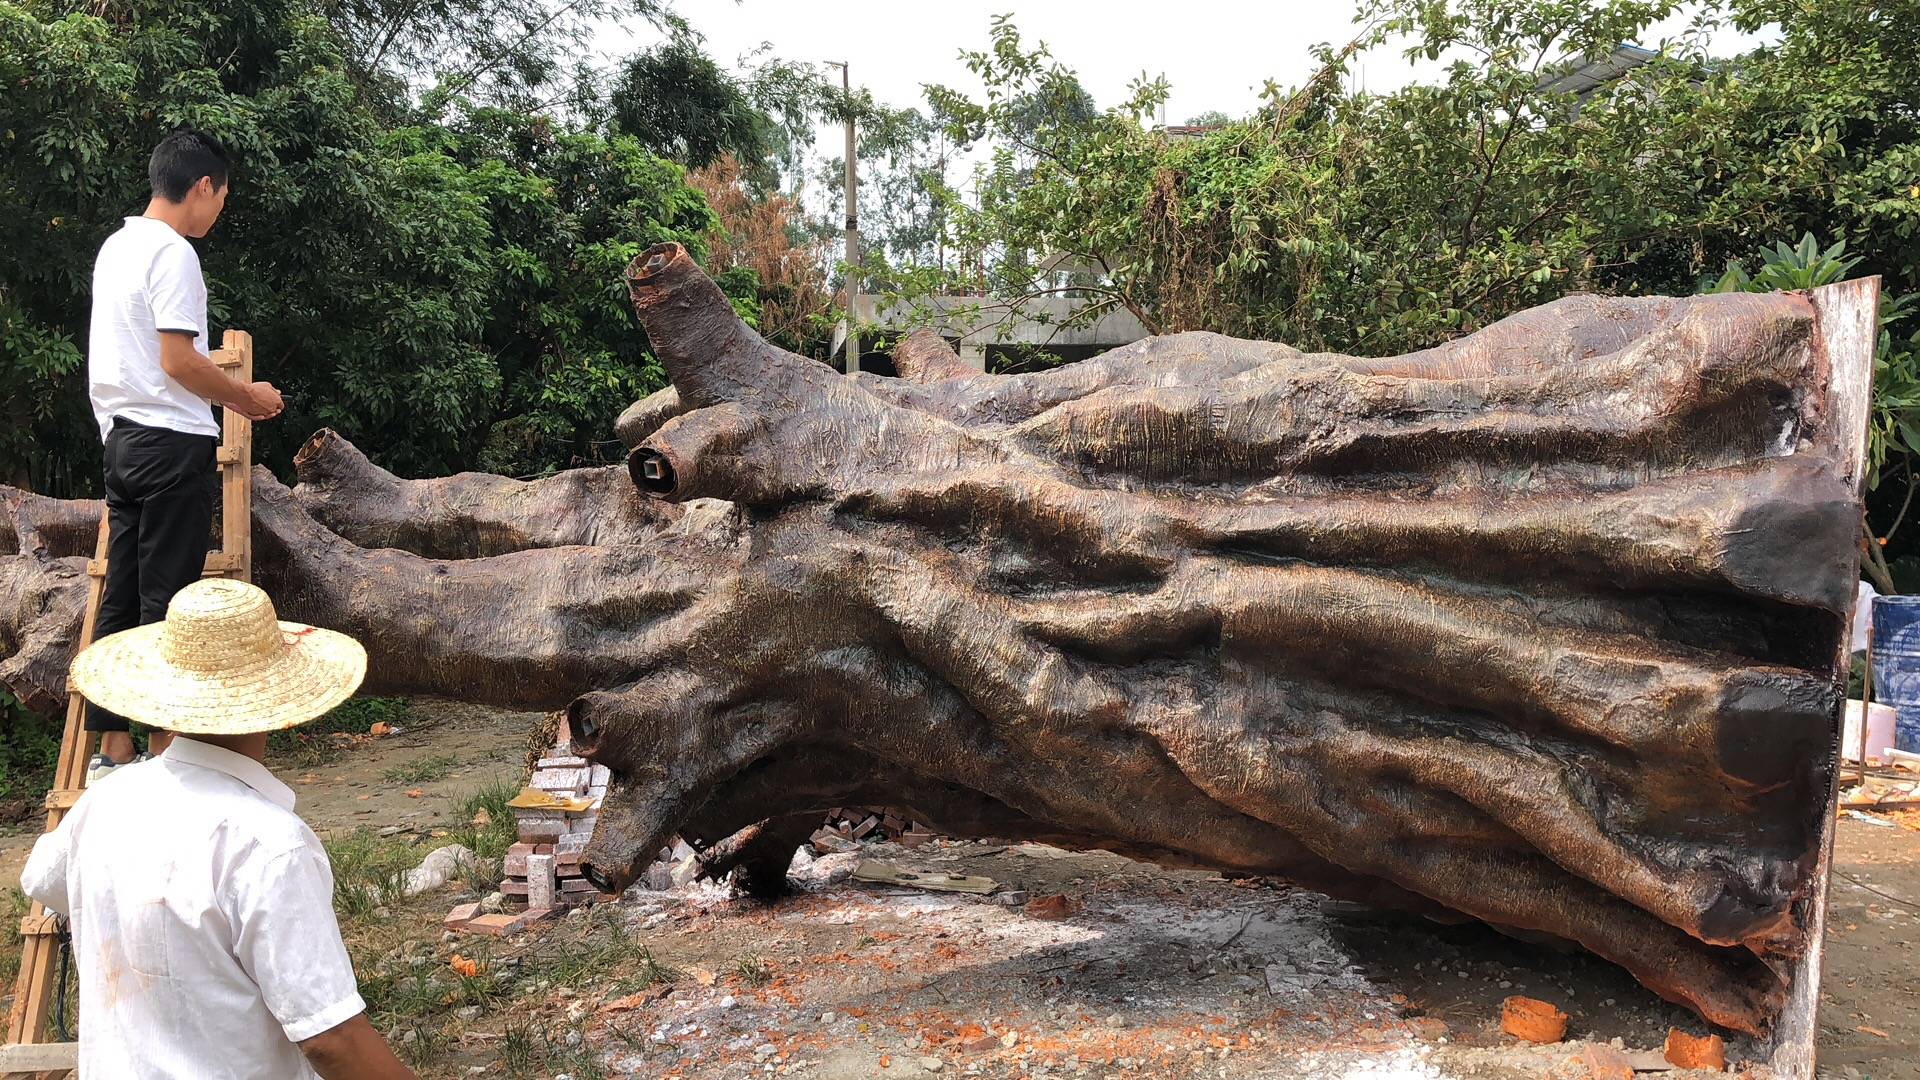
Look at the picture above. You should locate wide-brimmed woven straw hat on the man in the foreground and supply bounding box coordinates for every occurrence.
[67,578,367,734]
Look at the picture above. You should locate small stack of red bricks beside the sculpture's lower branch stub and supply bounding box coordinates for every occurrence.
[445,719,618,934]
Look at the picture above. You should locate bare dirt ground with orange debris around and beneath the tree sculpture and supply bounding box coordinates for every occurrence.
[0,705,1920,1080]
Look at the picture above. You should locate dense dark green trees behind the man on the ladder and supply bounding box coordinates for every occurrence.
[0,0,725,494]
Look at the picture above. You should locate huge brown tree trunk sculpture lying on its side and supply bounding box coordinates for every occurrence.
[0,246,1864,1032]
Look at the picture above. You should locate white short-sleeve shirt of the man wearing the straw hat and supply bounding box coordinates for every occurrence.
[21,736,367,1080]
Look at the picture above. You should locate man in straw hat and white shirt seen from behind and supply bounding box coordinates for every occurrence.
[21,578,413,1080]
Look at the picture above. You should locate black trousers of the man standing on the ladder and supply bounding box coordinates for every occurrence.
[86,417,217,732]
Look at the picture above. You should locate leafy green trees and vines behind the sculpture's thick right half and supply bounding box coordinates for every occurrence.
[897,0,1920,568]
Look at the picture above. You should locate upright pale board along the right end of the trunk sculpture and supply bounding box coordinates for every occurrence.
[1768,277,1880,1080]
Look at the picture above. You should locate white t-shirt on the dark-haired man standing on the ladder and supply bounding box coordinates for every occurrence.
[86,217,221,440]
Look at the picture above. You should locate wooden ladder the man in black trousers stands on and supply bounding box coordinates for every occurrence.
[0,331,253,1080]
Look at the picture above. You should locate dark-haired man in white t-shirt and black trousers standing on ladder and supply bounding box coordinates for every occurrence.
[86,131,282,782]
